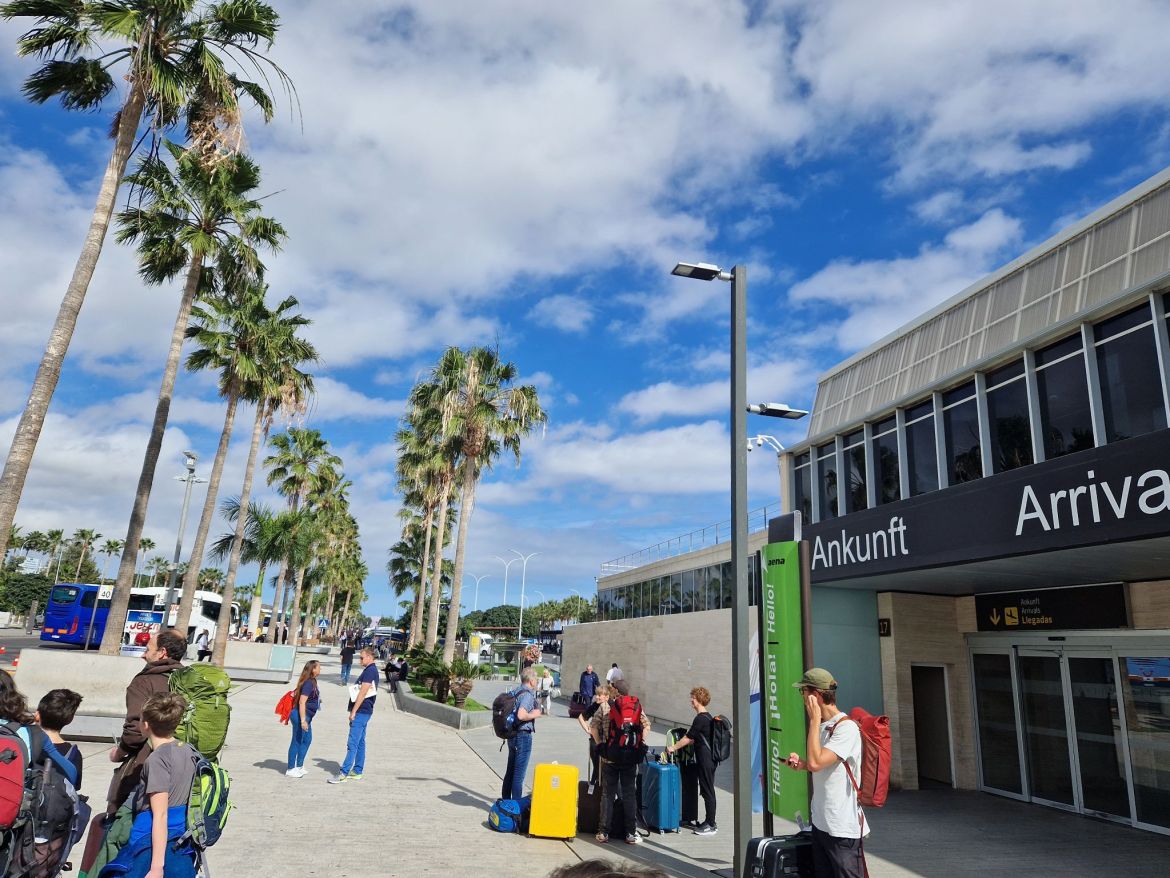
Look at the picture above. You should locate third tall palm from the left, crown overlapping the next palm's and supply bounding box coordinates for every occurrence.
[178,283,316,631]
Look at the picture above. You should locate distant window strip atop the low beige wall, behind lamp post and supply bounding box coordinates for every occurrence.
[597,554,759,622]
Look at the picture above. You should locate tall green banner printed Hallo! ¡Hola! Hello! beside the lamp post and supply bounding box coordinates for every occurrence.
[759,542,810,821]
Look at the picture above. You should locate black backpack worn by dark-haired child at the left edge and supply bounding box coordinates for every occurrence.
[5,727,91,878]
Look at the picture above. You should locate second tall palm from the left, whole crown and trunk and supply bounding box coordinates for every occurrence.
[101,143,284,656]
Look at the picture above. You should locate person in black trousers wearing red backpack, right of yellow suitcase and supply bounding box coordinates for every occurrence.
[590,678,651,844]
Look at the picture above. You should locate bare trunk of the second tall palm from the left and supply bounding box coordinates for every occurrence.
[99,255,202,656]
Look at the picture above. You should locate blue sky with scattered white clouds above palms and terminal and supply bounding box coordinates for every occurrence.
[0,0,1170,613]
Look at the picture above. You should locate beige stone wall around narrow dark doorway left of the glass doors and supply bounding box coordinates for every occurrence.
[878,591,976,789]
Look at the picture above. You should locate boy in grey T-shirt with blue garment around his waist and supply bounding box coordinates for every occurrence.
[99,692,197,878]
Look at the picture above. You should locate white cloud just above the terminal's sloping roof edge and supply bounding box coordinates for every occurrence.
[789,208,1021,350]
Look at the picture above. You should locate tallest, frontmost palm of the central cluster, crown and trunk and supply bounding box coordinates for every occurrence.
[424,348,548,663]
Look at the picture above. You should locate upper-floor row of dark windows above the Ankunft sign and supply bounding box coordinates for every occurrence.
[793,294,1170,521]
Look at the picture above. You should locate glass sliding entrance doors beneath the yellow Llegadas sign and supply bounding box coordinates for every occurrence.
[968,632,1170,834]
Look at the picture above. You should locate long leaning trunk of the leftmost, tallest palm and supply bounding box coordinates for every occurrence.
[0,85,145,564]
